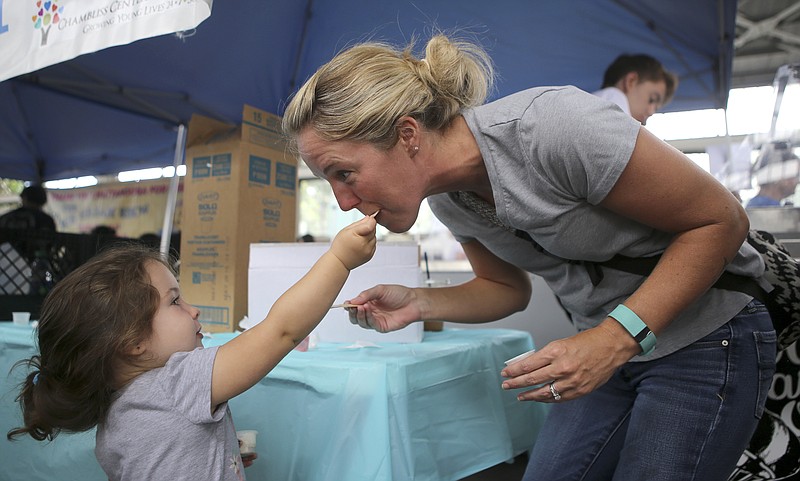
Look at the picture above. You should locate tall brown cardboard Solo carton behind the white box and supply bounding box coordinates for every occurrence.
[180,105,297,332]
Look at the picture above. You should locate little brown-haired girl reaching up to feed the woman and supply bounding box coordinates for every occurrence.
[8,216,376,480]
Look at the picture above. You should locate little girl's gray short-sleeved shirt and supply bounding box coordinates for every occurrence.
[95,347,245,481]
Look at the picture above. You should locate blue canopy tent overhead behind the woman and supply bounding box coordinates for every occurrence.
[0,0,736,181]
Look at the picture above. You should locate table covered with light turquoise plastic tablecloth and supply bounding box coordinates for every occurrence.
[0,323,547,481]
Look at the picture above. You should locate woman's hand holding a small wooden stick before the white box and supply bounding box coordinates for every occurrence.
[347,285,421,332]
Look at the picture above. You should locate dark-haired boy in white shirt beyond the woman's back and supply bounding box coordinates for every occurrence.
[593,54,678,125]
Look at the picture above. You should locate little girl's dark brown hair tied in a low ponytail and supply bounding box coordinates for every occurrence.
[7,243,170,441]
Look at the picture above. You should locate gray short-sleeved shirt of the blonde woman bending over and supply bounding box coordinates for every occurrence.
[428,86,764,360]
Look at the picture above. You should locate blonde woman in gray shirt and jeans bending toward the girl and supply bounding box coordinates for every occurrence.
[283,35,776,481]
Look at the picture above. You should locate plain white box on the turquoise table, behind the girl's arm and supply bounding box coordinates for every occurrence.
[248,242,423,344]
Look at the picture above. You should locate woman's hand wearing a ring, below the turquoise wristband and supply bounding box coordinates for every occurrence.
[500,318,641,402]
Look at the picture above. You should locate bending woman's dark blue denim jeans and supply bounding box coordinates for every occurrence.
[523,301,776,481]
